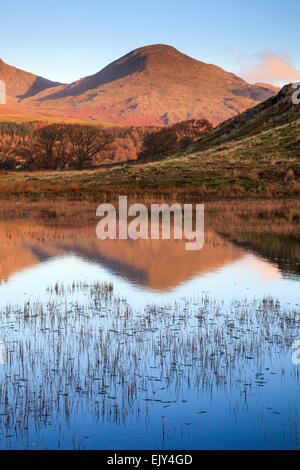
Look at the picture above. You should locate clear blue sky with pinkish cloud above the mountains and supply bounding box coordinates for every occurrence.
[0,0,300,84]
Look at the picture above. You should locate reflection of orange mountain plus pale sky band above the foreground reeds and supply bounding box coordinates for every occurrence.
[0,211,300,306]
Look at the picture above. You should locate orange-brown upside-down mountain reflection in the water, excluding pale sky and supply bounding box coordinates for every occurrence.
[0,219,300,292]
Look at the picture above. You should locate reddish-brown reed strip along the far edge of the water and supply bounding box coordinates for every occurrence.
[0,199,300,235]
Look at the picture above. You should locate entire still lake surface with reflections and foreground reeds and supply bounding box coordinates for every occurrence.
[0,202,300,449]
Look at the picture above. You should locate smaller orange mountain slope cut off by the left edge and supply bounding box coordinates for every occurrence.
[0,59,61,103]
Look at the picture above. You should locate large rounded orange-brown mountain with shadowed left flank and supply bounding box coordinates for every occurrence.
[0,44,275,125]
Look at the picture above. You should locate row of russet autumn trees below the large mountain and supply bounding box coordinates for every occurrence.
[0,119,212,170]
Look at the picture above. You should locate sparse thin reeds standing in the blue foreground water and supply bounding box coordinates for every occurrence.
[0,281,300,448]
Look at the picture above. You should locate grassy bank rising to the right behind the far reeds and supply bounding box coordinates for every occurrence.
[0,116,300,200]
